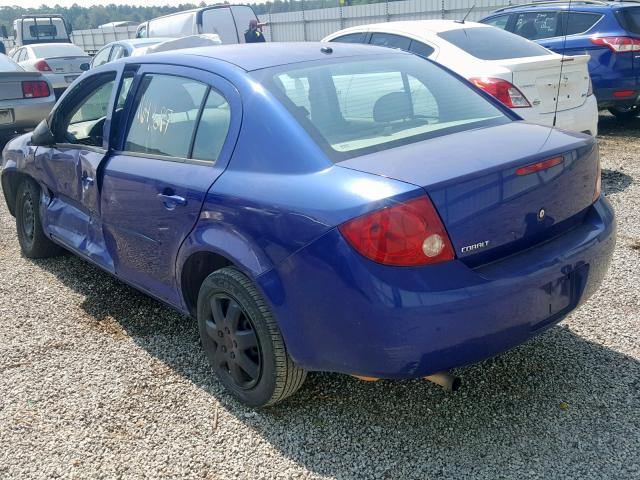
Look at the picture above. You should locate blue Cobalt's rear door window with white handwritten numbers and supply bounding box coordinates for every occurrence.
[124,73,208,158]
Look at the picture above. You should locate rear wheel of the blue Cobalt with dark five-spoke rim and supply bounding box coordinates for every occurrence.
[197,268,307,407]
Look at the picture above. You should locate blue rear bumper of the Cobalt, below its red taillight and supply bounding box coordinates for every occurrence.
[258,197,616,378]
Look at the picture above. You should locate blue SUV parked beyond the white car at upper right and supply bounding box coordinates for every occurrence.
[480,0,640,120]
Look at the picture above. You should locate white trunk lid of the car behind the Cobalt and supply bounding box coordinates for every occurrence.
[491,55,589,113]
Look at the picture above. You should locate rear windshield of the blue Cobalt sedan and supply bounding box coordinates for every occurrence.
[254,53,510,162]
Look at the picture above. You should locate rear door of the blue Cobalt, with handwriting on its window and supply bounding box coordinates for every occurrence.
[101,65,242,305]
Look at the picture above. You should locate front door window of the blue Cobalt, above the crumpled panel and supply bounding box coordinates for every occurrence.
[56,72,116,147]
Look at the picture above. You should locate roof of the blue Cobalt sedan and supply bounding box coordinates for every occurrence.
[152,42,410,71]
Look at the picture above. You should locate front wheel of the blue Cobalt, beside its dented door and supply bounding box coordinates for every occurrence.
[16,178,62,258]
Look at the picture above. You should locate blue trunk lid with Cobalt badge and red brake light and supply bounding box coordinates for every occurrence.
[339,122,598,264]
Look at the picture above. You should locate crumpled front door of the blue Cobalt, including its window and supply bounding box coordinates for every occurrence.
[36,71,117,271]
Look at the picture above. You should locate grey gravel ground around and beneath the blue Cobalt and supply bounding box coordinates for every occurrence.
[0,116,640,479]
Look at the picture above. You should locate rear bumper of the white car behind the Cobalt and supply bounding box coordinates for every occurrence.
[515,95,598,137]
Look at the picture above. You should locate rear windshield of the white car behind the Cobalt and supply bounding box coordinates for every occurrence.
[438,27,551,60]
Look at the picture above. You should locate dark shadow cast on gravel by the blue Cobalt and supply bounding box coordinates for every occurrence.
[32,256,640,479]
